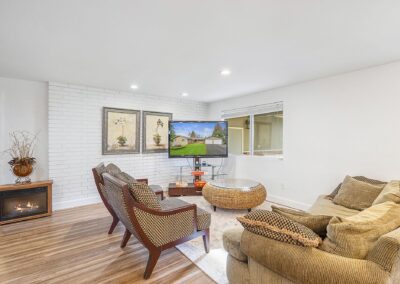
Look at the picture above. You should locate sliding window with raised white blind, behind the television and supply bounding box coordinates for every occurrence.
[222,103,283,156]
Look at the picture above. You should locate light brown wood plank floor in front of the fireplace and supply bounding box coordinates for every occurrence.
[0,204,214,284]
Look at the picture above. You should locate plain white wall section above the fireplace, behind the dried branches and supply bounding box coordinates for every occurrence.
[0,78,48,184]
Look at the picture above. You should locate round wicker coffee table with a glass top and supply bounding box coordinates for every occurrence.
[203,179,267,211]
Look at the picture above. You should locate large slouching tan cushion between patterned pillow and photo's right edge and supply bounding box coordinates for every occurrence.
[320,202,400,259]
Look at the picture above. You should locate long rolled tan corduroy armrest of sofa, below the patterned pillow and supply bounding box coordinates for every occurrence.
[240,230,390,284]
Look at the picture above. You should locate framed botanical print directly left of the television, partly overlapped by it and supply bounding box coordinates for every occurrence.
[142,111,172,153]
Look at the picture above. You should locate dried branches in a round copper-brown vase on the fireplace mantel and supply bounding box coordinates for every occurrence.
[6,131,37,183]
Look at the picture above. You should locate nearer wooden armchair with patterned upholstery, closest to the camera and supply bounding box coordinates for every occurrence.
[103,173,209,279]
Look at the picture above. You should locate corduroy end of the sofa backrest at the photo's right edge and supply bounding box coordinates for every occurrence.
[367,228,400,272]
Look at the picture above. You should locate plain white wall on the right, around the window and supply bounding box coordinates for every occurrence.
[209,63,400,208]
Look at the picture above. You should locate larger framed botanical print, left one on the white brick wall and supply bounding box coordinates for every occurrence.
[102,107,140,155]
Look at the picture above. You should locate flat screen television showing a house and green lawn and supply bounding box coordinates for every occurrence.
[168,121,228,158]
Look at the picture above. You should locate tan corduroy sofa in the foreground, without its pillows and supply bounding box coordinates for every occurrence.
[223,196,400,284]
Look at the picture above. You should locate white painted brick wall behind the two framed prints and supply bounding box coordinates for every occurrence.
[49,82,214,209]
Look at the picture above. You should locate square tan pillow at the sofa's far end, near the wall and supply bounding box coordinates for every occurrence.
[333,176,383,210]
